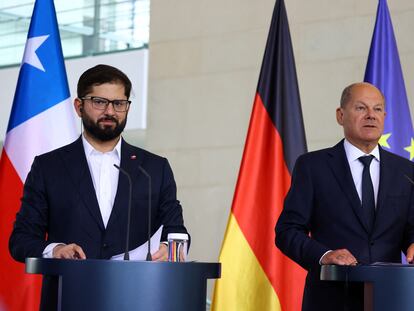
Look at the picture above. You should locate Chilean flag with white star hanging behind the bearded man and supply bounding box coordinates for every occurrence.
[0,0,78,311]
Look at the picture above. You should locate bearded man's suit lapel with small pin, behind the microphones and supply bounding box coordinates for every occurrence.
[107,139,143,227]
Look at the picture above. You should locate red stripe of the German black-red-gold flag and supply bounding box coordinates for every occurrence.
[232,94,306,311]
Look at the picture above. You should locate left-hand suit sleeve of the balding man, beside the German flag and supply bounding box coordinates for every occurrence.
[275,156,329,269]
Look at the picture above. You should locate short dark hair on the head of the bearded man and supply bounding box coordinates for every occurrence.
[77,64,132,99]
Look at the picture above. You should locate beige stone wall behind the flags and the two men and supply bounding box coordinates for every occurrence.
[146,0,414,298]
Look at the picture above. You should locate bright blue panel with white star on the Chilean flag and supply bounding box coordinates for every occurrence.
[7,0,70,132]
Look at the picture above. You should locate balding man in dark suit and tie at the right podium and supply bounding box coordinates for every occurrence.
[275,83,414,311]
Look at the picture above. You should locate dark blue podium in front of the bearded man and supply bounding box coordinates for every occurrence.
[26,258,221,311]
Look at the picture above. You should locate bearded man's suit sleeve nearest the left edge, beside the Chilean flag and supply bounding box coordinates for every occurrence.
[9,157,48,262]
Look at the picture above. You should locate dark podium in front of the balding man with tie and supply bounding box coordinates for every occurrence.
[321,264,414,311]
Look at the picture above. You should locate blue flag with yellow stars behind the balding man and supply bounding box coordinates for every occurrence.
[364,0,414,160]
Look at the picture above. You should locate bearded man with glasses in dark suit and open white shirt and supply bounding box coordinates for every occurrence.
[9,65,187,310]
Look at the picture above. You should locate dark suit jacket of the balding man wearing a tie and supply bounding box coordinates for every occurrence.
[276,141,414,311]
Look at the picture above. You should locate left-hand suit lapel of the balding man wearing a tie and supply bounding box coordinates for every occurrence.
[329,140,368,232]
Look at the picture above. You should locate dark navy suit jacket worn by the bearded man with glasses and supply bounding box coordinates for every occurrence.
[9,138,187,309]
